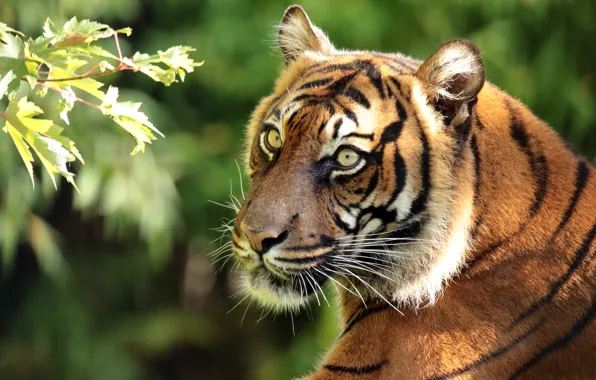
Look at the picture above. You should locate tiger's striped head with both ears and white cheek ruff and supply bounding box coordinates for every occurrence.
[232,6,484,309]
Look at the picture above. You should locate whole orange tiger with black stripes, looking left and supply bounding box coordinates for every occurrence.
[231,5,596,380]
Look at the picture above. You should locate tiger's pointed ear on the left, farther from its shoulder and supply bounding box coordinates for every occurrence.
[278,5,335,66]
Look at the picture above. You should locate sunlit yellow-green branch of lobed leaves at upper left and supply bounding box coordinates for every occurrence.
[0,17,202,190]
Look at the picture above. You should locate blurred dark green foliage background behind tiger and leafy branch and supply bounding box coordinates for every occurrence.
[0,0,596,380]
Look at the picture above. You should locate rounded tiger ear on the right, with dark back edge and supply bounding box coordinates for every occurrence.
[416,40,484,125]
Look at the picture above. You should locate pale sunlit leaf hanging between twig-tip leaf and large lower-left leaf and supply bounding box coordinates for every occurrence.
[101,86,163,156]
